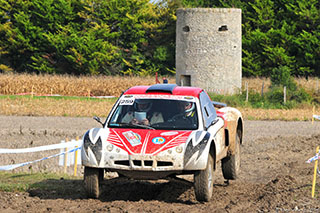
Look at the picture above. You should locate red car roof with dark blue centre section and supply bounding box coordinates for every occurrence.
[124,84,203,97]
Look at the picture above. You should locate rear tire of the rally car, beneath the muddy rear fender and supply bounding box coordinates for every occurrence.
[221,131,241,180]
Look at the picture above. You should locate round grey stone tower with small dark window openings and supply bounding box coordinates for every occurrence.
[176,8,242,94]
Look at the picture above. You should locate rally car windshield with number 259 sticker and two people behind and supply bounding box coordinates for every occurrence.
[108,96,198,130]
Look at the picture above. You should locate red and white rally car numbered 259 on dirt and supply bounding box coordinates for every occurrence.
[81,84,243,201]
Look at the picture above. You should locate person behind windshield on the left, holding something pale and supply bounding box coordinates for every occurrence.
[122,99,163,126]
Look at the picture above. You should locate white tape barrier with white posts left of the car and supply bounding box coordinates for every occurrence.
[0,140,82,171]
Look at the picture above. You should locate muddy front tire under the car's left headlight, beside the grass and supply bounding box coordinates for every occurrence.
[84,167,103,198]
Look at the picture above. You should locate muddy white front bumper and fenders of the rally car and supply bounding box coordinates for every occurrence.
[81,128,210,172]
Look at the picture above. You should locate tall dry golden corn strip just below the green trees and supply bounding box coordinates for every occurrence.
[0,74,319,96]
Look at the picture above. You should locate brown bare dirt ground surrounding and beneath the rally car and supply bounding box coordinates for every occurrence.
[0,116,320,212]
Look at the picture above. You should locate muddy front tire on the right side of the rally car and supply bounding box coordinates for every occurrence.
[194,154,213,202]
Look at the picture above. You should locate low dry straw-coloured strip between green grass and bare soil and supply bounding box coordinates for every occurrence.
[0,98,320,121]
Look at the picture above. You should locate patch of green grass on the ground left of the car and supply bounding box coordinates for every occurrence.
[0,171,80,192]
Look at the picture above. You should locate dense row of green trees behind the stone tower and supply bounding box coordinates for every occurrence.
[0,0,320,77]
